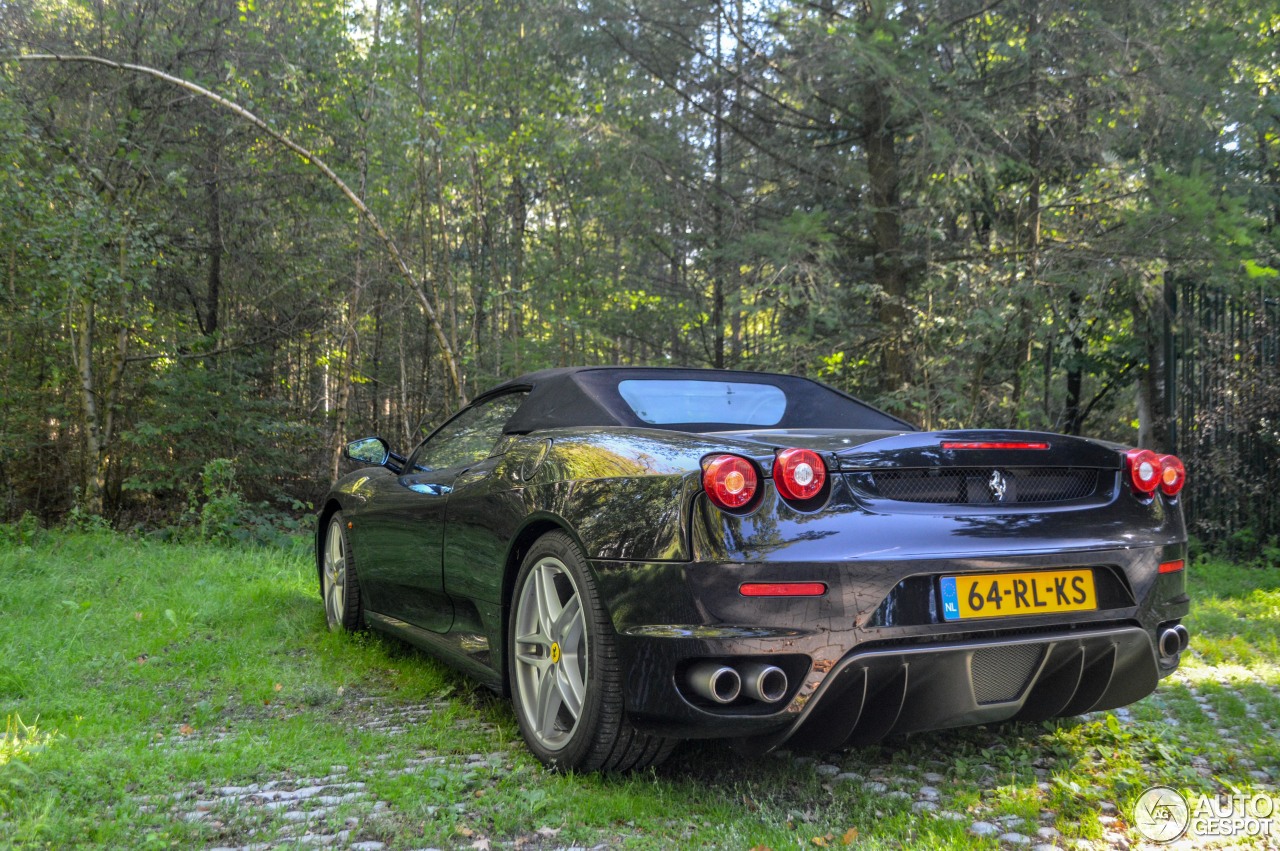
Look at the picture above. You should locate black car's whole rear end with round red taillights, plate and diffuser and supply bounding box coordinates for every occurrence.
[602,431,1188,747]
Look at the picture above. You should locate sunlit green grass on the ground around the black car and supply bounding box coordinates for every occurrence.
[0,530,1280,848]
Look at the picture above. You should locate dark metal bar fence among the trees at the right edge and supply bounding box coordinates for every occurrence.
[1165,275,1280,552]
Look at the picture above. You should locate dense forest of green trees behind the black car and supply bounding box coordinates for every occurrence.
[0,0,1280,557]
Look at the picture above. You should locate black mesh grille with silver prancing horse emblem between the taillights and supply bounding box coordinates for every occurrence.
[854,467,1098,504]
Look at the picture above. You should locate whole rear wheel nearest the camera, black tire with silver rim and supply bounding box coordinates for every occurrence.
[507,532,676,772]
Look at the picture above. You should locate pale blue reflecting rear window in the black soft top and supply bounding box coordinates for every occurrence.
[618,379,787,426]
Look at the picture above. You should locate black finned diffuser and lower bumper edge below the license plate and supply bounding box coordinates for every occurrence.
[623,626,1176,750]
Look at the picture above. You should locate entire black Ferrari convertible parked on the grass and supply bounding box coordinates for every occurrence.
[316,367,1189,770]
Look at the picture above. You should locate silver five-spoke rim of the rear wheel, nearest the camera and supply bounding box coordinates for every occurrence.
[513,555,588,751]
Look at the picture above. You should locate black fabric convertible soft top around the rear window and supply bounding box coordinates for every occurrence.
[480,366,915,434]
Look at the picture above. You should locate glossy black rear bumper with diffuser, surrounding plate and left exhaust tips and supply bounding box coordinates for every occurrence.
[596,546,1189,749]
